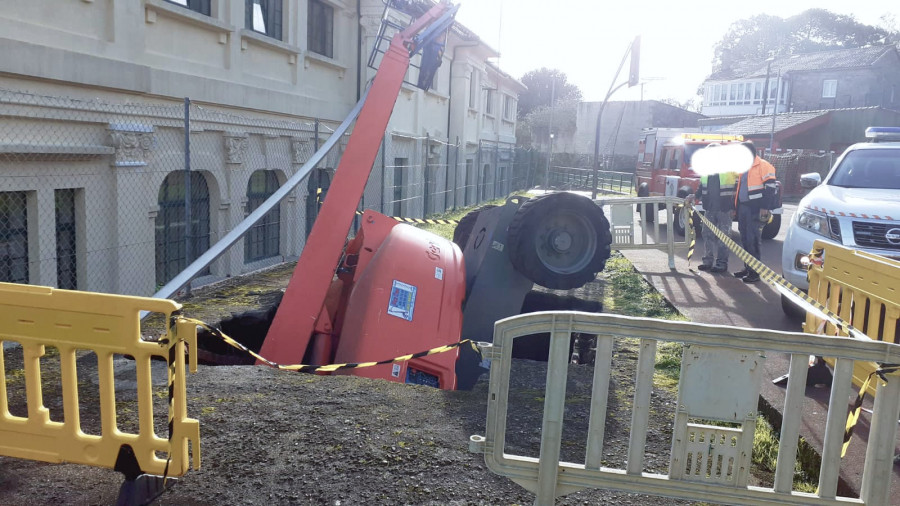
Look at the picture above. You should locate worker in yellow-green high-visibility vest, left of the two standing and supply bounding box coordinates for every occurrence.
[685,143,738,272]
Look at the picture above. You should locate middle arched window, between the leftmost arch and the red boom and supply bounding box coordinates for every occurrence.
[244,170,281,263]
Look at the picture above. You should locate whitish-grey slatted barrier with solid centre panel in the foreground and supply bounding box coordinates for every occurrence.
[470,312,900,505]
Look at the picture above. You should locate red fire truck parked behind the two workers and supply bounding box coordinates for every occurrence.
[634,128,781,239]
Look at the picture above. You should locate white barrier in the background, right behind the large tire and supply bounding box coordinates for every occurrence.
[594,197,694,269]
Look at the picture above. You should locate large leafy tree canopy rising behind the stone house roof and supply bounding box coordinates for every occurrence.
[713,9,897,73]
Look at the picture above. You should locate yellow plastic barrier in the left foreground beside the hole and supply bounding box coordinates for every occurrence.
[0,283,200,476]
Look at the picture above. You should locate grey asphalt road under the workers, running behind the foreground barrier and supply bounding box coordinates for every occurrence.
[622,204,900,504]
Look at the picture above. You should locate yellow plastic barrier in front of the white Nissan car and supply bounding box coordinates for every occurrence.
[803,241,900,395]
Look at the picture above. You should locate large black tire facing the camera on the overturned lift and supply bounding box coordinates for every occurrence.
[507,193,612,290]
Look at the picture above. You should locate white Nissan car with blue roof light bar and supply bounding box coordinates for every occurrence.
[781,127,900,314]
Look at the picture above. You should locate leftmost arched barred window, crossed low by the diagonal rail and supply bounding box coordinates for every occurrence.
[156,172,209,286]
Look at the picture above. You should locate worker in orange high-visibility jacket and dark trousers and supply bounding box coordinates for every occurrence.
[734,141,776,283]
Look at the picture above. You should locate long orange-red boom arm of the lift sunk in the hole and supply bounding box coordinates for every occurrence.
[260,2,462,371]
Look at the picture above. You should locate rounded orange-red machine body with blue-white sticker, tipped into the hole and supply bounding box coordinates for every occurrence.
[332,211,466,389]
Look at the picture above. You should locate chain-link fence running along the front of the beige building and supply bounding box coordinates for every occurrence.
[0,90,533,295]
